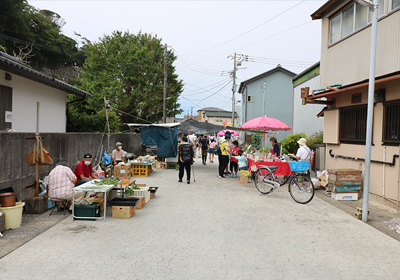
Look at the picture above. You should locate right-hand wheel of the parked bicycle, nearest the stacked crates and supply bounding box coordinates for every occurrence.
[289,174,315,204]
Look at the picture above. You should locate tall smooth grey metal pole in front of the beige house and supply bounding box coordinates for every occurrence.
[362,0,379,222]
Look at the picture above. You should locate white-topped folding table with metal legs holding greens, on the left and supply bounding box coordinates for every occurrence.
[72,179,122,221]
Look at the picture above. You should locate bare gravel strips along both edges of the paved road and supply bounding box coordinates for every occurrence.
[0,186,400,259]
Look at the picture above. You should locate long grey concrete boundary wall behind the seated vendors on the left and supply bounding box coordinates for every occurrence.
[0,132,142,200]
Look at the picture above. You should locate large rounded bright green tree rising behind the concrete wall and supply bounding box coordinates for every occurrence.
[73,31,183,129]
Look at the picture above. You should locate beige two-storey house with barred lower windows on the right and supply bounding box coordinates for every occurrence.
[307,0,400,206]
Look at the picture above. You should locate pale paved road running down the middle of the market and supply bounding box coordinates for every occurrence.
[0,159,400,280]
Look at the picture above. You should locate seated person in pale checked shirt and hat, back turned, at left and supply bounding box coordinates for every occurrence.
[47,158,85,210]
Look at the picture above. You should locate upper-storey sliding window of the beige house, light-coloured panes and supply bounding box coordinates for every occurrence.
[329,0,384,44]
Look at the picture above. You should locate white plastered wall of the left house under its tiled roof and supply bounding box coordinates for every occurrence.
[0,70,67,132]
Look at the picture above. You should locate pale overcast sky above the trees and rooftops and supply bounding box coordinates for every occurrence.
[28,0,326,120]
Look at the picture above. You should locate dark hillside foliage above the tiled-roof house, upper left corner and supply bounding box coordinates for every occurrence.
[0,0,83,69]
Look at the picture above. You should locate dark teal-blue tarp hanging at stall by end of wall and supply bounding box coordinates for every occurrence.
[140,126,178,158]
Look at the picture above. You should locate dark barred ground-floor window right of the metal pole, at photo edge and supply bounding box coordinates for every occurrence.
[383,101,400,144]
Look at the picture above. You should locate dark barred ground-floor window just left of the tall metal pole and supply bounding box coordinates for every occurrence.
[339,106,367,143]
